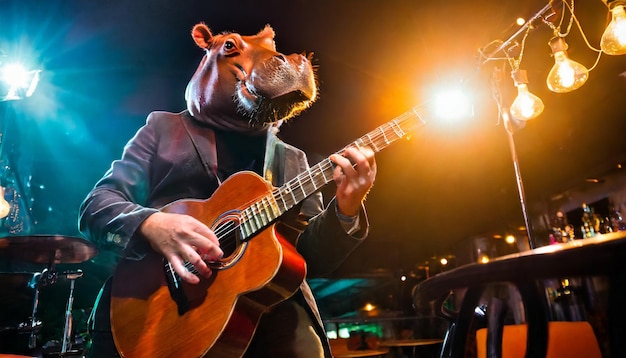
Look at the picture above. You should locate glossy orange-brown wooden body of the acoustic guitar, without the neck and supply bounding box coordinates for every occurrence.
[111,172,306,358]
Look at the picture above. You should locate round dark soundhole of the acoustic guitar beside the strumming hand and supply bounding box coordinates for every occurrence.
[211,212,246,268]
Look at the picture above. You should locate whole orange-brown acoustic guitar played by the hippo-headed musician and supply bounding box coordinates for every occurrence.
[111,107,424,358]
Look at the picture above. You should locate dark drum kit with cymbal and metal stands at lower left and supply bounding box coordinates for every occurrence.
[0,235,98,358]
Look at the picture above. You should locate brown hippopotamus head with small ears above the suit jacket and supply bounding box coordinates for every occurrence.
[185,23,317,131]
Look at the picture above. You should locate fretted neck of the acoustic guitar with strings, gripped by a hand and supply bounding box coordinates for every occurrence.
[240,103,426,241]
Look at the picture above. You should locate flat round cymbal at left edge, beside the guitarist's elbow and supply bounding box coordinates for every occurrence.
[0,235,98,264]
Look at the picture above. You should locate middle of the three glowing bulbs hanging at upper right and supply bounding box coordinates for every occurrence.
[546,37,589,93]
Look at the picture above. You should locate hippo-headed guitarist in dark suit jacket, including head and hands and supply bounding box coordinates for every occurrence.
[79,24,376,357]
